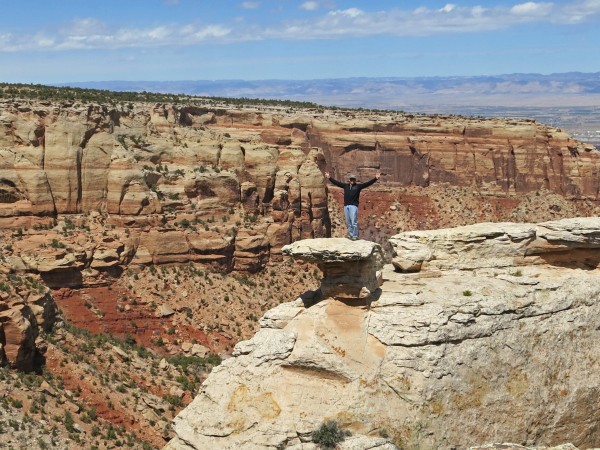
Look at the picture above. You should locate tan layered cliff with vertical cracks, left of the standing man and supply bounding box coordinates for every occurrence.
[0,101,329,285]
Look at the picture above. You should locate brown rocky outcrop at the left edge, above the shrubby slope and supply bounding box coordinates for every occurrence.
[0,264,58,371]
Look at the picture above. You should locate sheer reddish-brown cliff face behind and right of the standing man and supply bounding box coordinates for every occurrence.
[308,113,599,199]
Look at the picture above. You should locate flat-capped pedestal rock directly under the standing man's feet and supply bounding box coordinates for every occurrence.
[282,238,383,300]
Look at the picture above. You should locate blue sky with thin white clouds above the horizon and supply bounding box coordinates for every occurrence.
[0,0,600,83]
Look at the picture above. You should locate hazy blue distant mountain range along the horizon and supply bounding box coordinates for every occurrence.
[59,72,600,110]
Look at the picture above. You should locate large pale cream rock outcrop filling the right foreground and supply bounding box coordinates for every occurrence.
[167,218,600,449]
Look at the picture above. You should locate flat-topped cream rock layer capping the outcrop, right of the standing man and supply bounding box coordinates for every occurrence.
[390,217,600,272]
